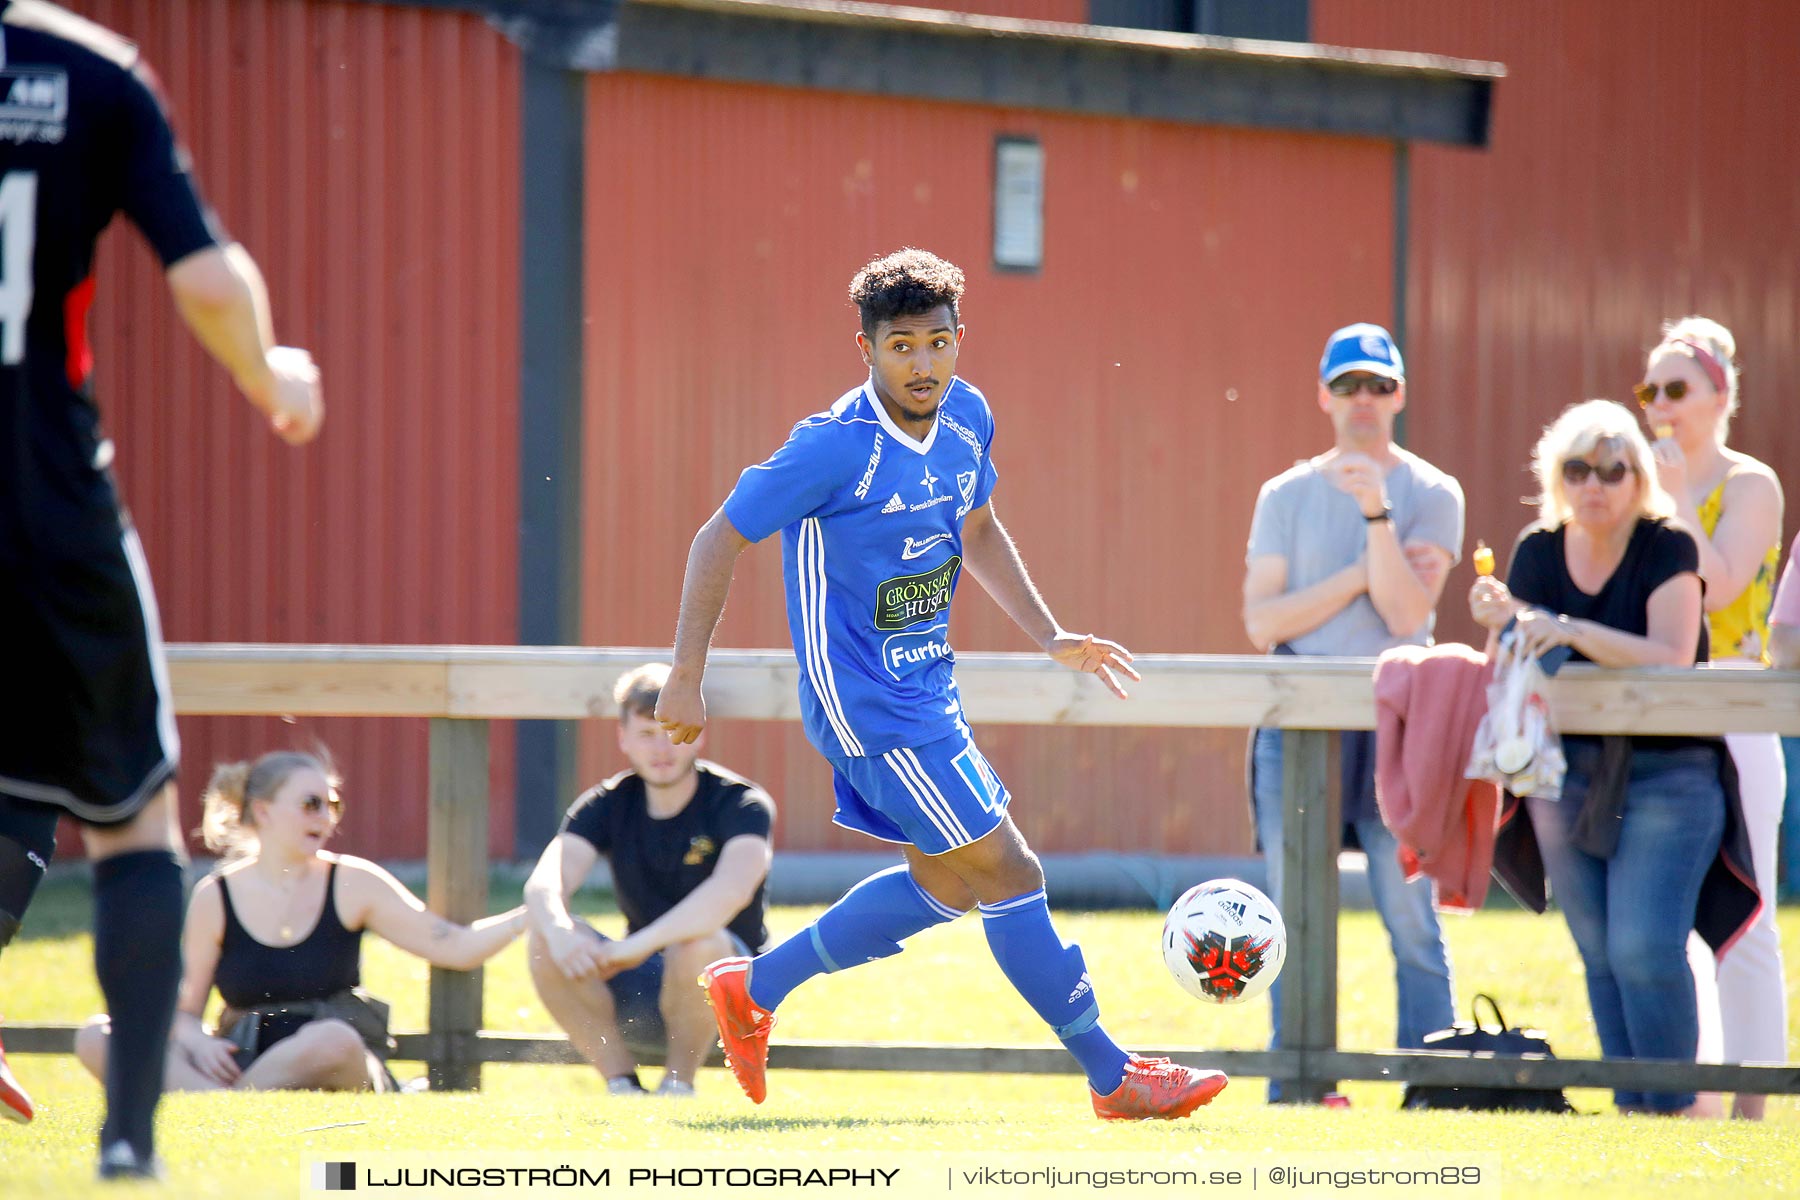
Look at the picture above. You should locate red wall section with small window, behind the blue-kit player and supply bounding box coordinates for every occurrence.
[583,76,1393,853]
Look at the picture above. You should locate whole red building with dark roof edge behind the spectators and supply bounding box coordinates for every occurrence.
[59,0,1800,856]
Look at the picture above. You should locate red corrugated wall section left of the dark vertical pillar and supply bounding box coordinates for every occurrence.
[72,0,518,858]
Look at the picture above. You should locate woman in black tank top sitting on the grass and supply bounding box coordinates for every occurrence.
[76,750,526,1092]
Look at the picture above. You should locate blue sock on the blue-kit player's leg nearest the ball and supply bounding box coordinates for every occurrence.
[979,889,1130,1096]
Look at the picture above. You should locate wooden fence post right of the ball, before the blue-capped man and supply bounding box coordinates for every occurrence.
[1282,729,1343,1103]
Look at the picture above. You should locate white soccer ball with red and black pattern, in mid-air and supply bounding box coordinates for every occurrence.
[1163,880,1287,1004]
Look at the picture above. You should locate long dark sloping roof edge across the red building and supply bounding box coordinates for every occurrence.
[358,0,1507,146]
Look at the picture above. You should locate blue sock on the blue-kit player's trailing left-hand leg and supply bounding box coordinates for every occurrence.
[749,865,963,1011]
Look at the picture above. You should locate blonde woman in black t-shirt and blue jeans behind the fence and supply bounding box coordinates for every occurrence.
[1469,399,1757,1114]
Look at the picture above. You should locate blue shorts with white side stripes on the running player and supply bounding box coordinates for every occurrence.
[826,732,1012,855]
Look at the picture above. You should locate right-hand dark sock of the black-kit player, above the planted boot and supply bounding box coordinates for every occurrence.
[94,849,182,1162]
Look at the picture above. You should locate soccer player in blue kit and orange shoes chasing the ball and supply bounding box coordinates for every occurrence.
[657,248,1226,1119]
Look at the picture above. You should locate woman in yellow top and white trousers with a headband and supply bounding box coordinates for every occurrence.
[1634,317,1787,1119]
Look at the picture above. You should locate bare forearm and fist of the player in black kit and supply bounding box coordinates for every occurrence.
[166,243,324,446]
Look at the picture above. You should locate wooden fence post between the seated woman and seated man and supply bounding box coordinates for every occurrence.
[427,718,488,1092]
